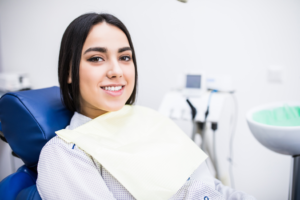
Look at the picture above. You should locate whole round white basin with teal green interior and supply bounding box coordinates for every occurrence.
[246,103,300,155]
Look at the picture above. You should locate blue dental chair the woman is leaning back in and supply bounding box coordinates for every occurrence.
[0,87,73,200]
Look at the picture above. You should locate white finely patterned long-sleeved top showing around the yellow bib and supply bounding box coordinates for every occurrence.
[36,113,254,200]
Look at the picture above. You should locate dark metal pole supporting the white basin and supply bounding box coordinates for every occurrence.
[291,155,300,200]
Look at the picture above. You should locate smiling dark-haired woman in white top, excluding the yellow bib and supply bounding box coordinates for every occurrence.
[37,13,254,200]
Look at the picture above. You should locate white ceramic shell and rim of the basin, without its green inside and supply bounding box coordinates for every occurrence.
[246,103,300,155]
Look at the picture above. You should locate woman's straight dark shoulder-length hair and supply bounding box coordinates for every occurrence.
[58,13,138,112]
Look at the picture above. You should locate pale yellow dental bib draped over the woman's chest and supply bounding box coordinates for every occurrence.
[56,105,207,200]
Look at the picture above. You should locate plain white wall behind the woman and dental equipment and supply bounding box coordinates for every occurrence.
[0,0,300,200]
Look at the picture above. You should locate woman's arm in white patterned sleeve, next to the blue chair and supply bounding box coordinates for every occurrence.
[37,137,115,200]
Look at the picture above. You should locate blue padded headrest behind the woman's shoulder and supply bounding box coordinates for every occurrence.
[0,87,73,168]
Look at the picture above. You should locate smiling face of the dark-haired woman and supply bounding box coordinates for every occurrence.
[69,22,135,118]
